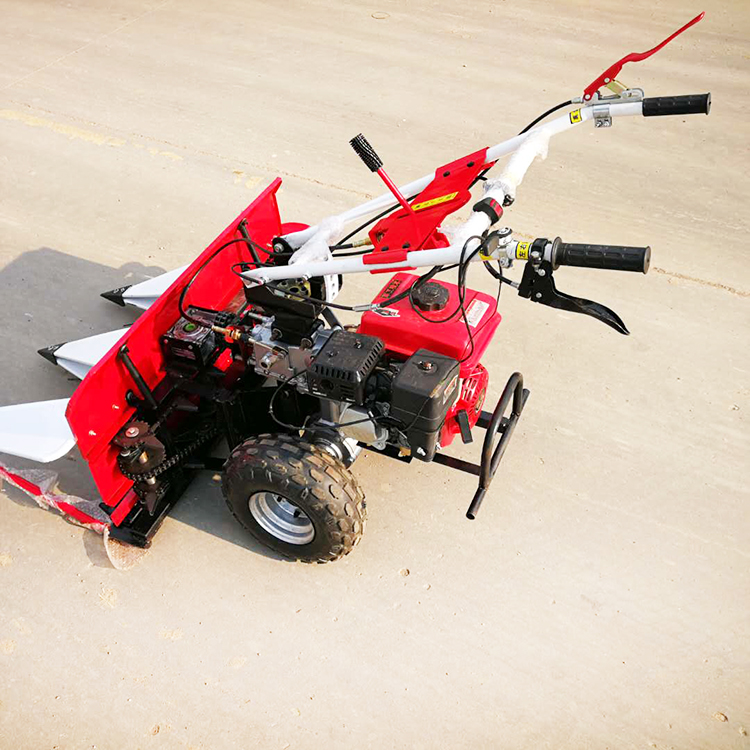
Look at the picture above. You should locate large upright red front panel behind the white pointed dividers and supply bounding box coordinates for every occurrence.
[66,178,294,506]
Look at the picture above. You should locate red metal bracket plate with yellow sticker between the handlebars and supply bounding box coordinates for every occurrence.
[363,148,494,264]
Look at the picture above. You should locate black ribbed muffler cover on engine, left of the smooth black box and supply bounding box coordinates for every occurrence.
[307,331,384,404]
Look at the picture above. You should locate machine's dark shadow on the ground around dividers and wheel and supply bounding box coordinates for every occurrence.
[0,247,282,566]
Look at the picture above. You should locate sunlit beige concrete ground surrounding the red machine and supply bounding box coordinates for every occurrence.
[0,0,750,750]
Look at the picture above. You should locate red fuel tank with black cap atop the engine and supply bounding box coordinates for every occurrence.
[358,273,501,378]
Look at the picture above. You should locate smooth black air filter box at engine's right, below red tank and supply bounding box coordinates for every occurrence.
[391,349,460,461]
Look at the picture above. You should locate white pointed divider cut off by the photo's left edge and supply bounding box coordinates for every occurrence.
[0,398,76,463]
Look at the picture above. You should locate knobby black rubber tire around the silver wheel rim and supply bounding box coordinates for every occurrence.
[222,434,367,563]
